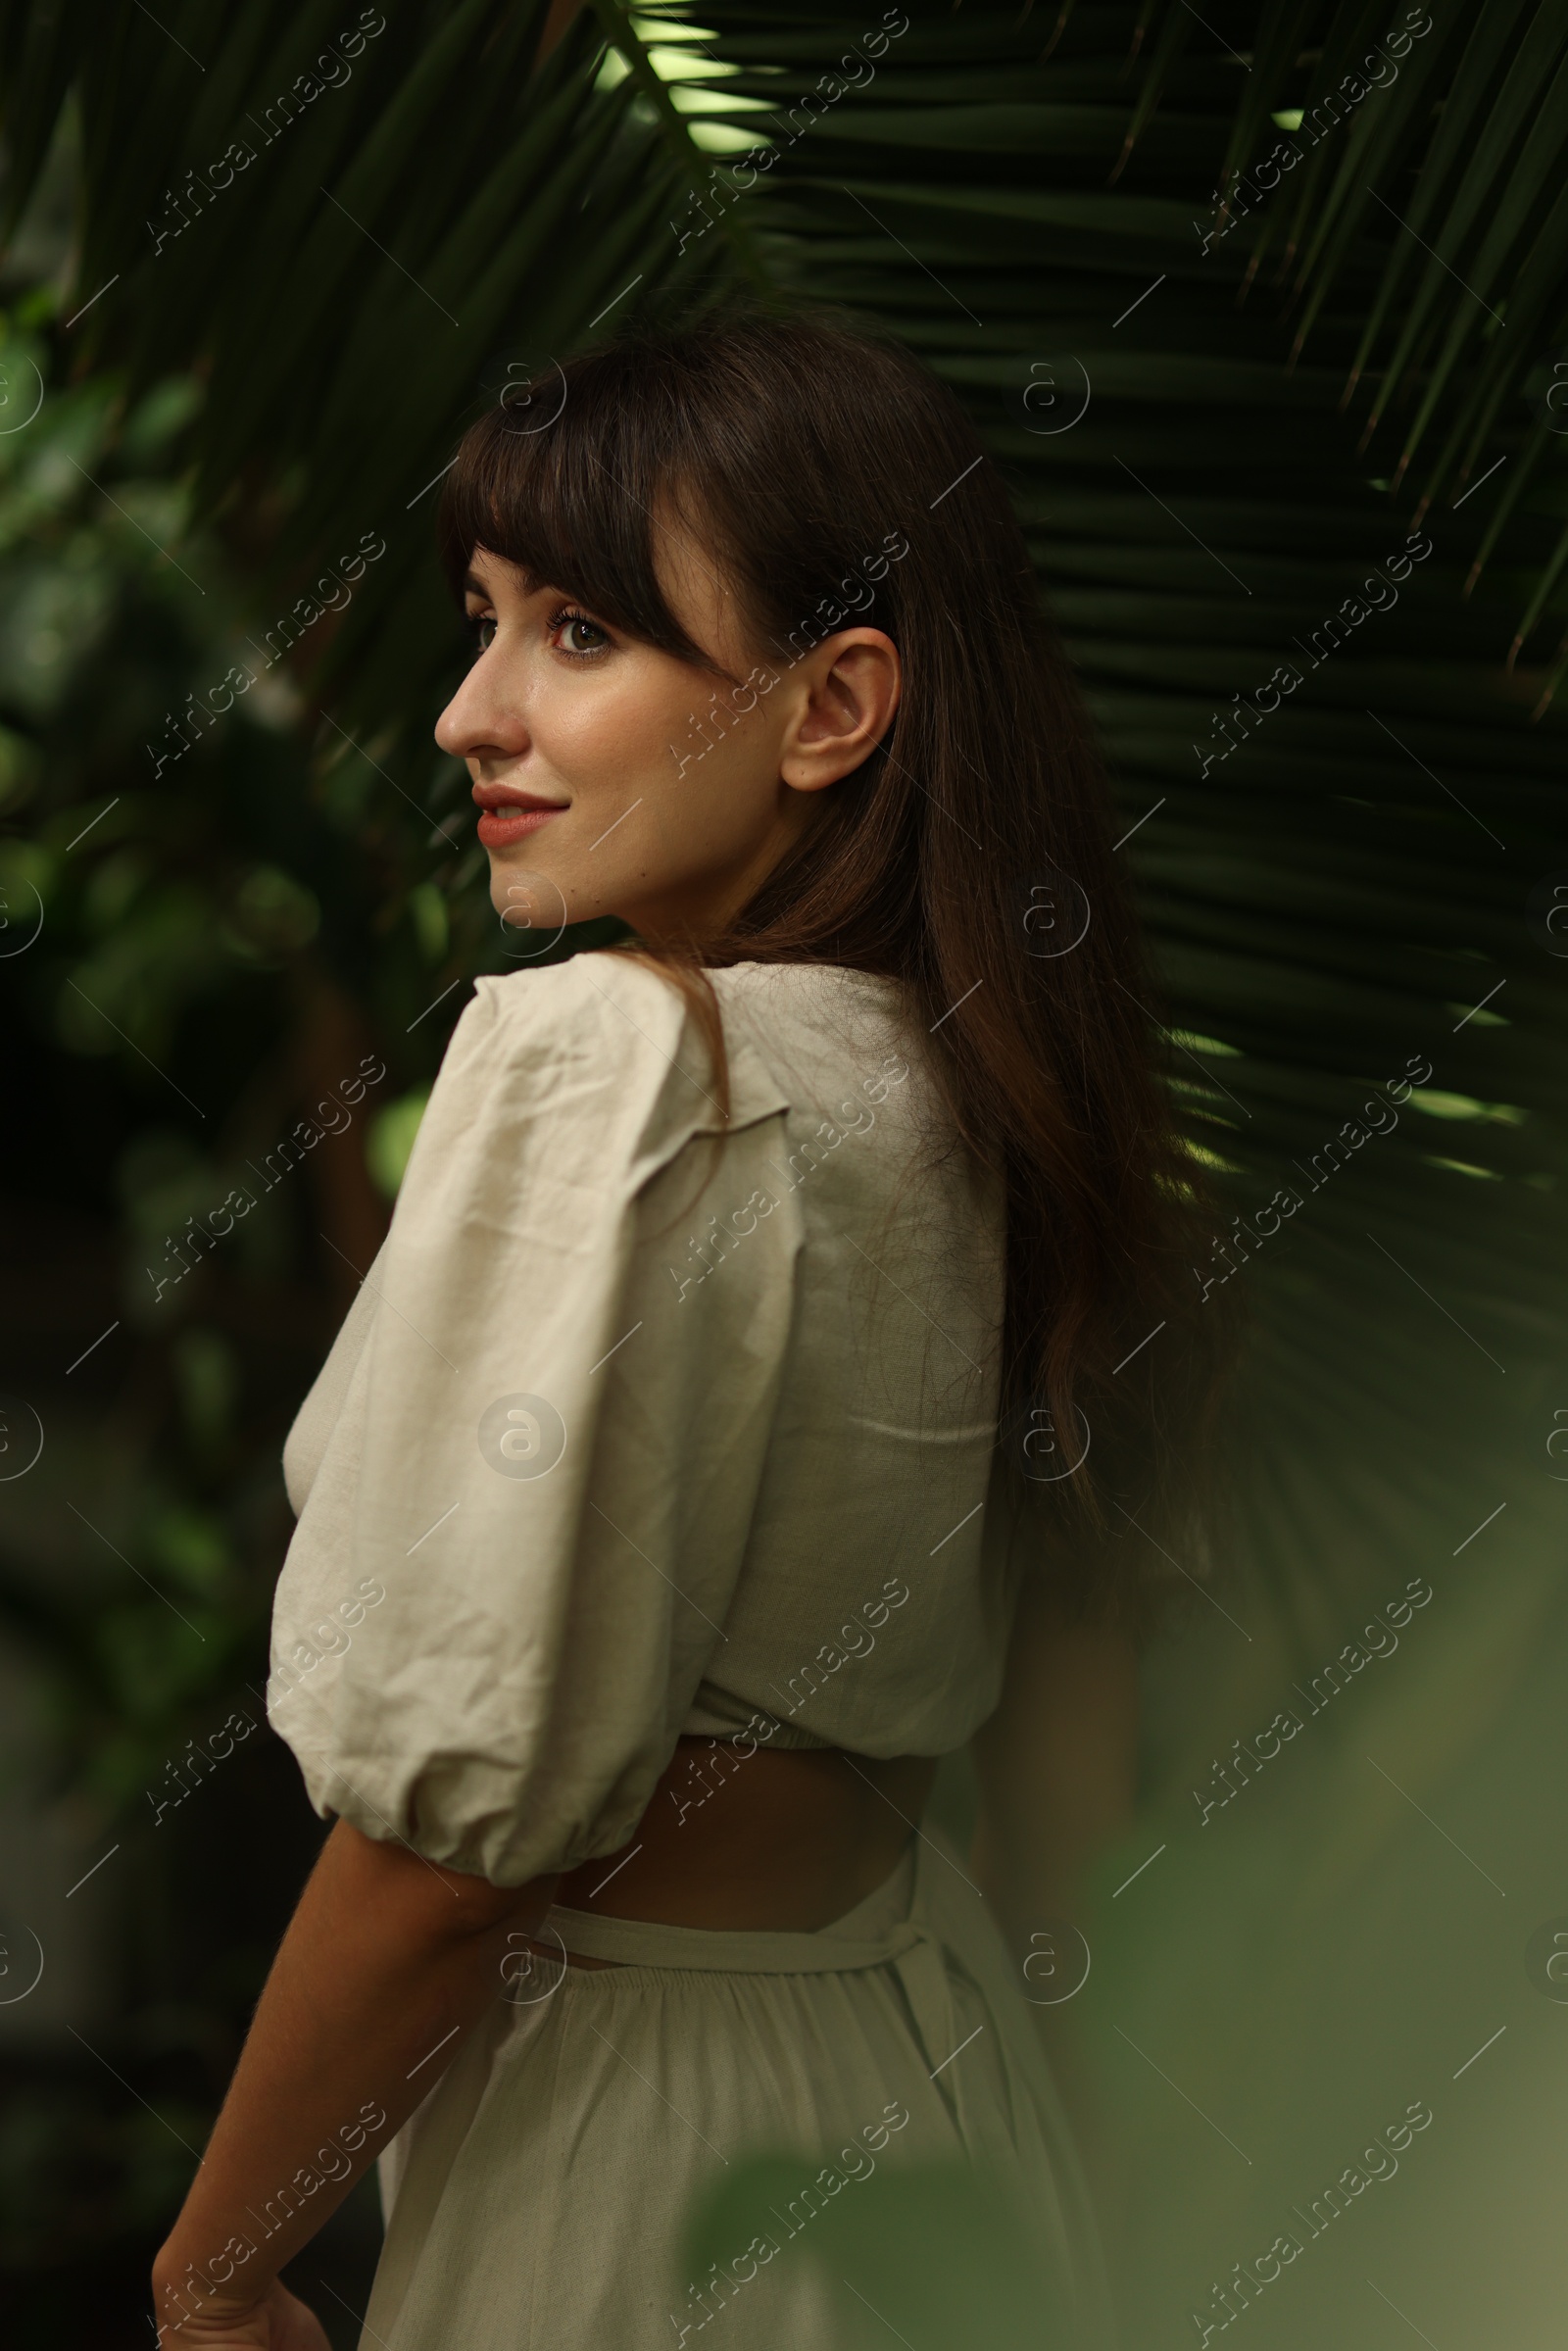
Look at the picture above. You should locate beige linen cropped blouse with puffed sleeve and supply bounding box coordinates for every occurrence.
[268,953,1015,1886]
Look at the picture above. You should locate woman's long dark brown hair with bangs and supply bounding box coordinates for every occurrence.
[440,313,1230,1606]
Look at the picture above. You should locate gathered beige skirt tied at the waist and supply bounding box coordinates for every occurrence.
[360,1832,1112,2351]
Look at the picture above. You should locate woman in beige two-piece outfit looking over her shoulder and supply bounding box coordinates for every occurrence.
[155,319,1210,2351]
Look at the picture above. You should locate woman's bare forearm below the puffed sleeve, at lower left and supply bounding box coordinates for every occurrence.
[153,1820,555,2346]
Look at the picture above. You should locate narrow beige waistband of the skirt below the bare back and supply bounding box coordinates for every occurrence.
[538,1837,921,1975]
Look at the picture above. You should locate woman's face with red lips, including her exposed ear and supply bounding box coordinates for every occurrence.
[435,541,901,941]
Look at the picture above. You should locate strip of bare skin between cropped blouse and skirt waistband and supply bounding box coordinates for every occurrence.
[536,1738,936,1968]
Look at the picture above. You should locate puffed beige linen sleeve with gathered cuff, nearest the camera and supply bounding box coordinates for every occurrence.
[268,953,802,1886]
